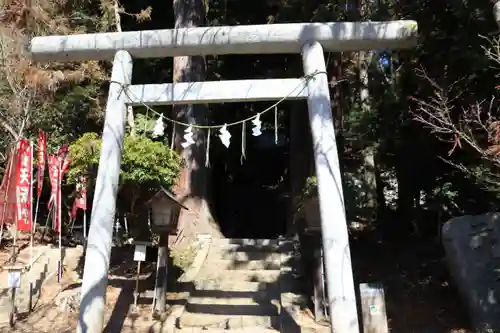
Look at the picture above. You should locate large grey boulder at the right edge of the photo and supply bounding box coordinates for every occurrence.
[442,213,500,333]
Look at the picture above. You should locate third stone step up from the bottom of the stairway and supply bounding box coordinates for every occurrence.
[194,280,280,297]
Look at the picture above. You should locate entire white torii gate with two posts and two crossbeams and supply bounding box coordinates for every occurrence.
[29,21,417,333]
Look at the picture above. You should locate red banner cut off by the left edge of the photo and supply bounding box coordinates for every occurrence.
[0,150,17,225]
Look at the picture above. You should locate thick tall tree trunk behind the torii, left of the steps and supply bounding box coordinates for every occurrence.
[173,0,218,244]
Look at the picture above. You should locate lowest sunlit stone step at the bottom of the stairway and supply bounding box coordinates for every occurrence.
[178,306,279,330]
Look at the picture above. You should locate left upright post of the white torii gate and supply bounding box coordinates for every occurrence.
[77,51,132,333]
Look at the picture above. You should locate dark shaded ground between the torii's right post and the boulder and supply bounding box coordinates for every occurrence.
[351,232,472,333]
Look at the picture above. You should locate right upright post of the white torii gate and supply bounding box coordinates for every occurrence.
[302,42,359,333]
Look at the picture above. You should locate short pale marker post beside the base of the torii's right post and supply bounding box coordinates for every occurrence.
[359,283,389,333]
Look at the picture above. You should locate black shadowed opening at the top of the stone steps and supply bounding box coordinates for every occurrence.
[212,115,290,238]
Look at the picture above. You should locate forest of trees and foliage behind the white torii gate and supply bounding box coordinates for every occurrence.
[0,0,500,244]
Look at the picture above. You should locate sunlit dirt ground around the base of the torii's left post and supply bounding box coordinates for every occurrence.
[0,244,160,333]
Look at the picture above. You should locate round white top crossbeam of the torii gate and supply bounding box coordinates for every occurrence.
[29,20,417,62]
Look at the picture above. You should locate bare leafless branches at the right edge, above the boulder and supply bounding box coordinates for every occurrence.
[410,38,500,190]
